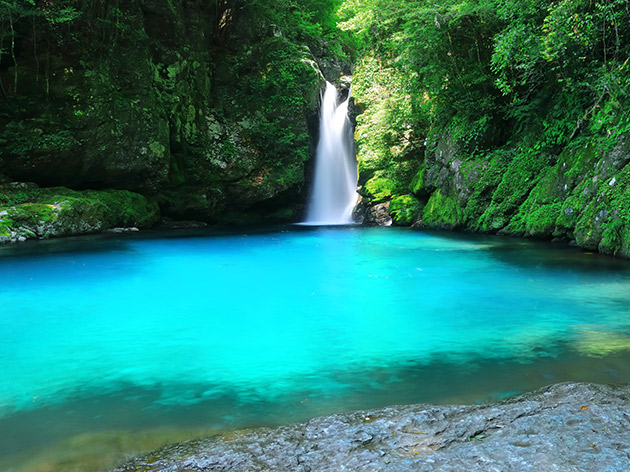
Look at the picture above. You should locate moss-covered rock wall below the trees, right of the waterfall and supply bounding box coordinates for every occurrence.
[404,135,630,257]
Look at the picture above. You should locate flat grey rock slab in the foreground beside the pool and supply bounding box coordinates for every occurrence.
[113,383,630,472]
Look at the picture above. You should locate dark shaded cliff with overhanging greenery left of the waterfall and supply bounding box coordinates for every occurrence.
[0,0,354,239]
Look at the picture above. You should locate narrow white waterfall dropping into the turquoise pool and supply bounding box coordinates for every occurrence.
[305,82,358,225]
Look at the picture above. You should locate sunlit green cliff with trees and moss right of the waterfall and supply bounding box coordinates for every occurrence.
[342,0,630,257]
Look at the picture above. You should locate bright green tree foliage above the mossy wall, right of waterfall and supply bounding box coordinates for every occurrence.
[339,0,630,206]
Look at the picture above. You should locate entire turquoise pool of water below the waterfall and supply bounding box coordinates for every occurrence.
[0,227,630,471]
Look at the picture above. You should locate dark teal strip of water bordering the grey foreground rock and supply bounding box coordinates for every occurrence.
[0,344,630,463]
